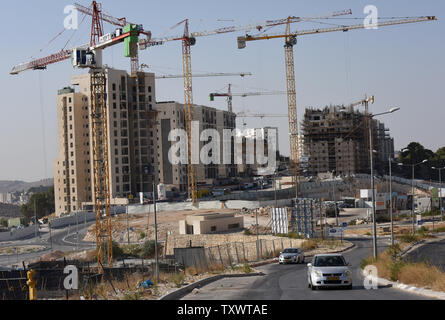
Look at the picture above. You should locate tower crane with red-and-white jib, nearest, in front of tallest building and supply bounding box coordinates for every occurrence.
[10,1,151,271]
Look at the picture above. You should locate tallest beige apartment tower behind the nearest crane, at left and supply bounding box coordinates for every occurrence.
[54,68,157,215]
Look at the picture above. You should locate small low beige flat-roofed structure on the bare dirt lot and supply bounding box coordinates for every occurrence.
[179,213,244,234]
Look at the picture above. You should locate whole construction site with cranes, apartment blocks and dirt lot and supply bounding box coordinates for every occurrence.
[0,1,442,300]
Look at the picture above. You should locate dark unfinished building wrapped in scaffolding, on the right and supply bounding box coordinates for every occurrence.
[301,106,394,175]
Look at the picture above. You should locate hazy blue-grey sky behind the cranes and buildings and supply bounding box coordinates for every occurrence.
[0,0,445,181]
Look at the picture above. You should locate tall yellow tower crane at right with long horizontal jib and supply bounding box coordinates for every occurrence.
[238,16,437,197]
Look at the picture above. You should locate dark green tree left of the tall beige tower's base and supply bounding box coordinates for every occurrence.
[20,187,56,222]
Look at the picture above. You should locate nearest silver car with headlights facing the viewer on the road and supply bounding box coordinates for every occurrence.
[307,254,352,290]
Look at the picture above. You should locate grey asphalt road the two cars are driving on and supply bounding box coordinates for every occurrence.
[183,239,427,301]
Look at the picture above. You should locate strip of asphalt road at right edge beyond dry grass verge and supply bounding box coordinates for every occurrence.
[405,240,445,272]
